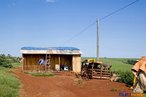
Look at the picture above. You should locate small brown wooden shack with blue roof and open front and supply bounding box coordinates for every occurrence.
[20,47,81,72]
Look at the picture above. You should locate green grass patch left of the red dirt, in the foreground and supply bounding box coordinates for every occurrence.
[0,64,20,97]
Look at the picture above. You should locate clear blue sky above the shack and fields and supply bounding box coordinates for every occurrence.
[0,0,146,58]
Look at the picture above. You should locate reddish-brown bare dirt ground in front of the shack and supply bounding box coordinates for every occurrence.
[14,69,132,97]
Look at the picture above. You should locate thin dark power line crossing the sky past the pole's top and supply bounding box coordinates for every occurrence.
[64,0,140,44]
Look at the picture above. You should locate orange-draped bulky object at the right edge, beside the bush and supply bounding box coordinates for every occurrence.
[132,56,146,93]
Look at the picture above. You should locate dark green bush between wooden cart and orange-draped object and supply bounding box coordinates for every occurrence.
[117,71,134,86]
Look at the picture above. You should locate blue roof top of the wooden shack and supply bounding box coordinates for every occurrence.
[21,47,80,50]
